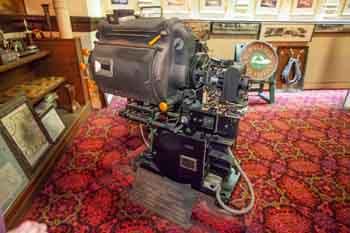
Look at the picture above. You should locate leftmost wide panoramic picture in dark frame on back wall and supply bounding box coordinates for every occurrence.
[211,22,260,36]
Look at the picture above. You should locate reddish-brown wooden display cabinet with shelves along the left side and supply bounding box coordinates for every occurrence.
[0,38,91,228]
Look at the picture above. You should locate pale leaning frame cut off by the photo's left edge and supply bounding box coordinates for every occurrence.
[0,133,29,213]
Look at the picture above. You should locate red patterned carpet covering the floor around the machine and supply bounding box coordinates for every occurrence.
[26,91,350,233]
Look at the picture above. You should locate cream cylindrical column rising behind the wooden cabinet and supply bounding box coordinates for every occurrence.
[53,0,73,39]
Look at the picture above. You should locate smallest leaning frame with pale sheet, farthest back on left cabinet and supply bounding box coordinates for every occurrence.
[41,108,66,143]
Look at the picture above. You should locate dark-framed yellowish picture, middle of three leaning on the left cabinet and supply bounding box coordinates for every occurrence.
[0,97,50,170]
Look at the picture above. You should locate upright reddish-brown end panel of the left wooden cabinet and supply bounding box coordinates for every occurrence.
[34,38,88,105]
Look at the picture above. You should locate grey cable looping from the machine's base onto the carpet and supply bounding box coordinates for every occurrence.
[216,149,255,215]
